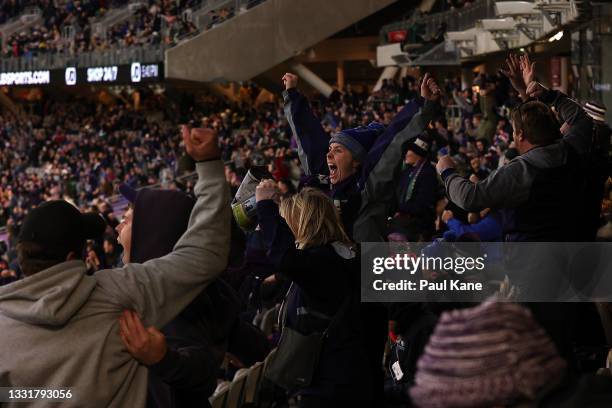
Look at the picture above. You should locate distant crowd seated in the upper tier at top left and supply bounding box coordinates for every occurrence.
[0,0,266,58]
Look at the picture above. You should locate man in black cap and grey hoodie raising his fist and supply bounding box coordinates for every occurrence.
[0,126,229,407]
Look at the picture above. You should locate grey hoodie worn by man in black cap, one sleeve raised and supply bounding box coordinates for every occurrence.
[0,161,230,408]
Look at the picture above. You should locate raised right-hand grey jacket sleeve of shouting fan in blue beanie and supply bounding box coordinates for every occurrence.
[353,102,437,242]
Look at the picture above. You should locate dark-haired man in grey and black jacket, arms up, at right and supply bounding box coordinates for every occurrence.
[437,52,595,241]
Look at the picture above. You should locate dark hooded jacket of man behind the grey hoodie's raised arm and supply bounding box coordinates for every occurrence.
[130,189,239,408]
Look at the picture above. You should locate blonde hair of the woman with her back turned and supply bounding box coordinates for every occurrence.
[280,188,351,249]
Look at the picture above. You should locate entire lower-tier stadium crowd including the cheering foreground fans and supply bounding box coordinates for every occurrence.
[0,51,612,407]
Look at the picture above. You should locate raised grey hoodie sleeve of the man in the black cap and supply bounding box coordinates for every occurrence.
[94,160,230,327]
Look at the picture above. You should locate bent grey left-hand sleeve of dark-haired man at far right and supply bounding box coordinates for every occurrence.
[443,157,533,211]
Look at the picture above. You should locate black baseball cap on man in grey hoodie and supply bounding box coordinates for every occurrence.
[19,200,106,259]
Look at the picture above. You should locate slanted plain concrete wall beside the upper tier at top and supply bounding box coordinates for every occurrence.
[166,0,396,82]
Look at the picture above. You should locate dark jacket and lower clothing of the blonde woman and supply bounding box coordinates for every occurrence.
[257,200,387,401]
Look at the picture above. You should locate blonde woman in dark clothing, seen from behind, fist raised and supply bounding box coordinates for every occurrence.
[257,181,386,407]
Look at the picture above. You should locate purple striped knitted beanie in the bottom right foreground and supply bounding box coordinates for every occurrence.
[410,300,566,408]
